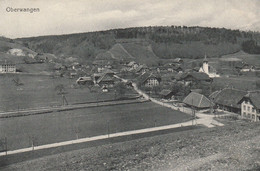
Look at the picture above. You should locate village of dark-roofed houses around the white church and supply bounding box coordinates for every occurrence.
[0,46,260,121]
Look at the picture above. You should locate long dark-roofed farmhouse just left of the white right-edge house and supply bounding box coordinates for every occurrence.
[210,88,247,114]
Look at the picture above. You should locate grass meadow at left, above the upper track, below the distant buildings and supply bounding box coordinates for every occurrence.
[0,74,136,111]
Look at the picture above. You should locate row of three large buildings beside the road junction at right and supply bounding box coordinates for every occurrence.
[183,88,260,121]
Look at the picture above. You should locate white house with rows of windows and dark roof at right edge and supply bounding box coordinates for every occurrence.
[238,91,260,121]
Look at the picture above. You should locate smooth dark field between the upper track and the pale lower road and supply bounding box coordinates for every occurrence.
[0,102,190,150]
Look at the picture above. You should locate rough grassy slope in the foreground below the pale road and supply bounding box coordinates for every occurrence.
[3,121,260,170]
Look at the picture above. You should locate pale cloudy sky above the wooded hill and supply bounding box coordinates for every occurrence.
[0,0,260,38]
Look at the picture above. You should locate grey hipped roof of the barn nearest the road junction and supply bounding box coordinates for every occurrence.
[183,92,211,108]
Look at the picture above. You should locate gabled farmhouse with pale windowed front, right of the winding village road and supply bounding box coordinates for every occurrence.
[137,72,161,87]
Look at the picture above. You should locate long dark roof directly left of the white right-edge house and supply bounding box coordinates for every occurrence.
[214,88,247,108]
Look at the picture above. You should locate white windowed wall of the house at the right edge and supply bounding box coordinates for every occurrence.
[241,100,260,121]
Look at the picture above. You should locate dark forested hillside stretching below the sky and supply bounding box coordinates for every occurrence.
[14,26,260,61]
